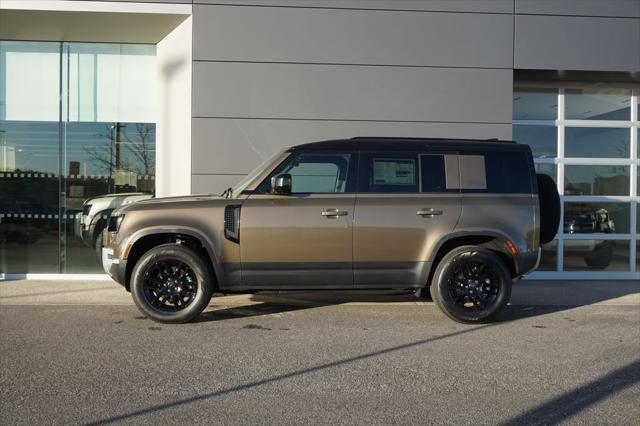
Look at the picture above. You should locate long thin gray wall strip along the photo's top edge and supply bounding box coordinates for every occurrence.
[194,0,513,13]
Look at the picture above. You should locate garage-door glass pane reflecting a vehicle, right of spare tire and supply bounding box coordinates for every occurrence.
[564,202,630,234]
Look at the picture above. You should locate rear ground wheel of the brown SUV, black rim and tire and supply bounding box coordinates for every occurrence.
[431,246,512,324]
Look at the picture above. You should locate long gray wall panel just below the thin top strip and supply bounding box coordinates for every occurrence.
[194,6,513,68]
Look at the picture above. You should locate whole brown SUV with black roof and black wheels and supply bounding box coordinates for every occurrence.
[102,137,560,323]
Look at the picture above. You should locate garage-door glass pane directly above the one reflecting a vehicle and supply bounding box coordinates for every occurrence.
[564,165,630,195]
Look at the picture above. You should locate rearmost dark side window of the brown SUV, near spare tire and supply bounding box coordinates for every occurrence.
[485,152,531,194]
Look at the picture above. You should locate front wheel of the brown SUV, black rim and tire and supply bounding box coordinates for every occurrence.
[131,244,214,323]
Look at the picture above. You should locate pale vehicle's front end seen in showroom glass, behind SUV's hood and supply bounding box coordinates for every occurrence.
[74,192,153,256]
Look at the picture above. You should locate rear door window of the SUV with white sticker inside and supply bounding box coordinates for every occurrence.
[358,153,418,192]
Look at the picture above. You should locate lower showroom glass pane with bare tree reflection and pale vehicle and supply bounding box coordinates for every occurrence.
[62,122,155,273]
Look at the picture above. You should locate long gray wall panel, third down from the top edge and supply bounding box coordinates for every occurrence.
[193,62,513,123]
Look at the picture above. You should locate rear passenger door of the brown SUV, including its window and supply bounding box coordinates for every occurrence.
[353,152,461,288]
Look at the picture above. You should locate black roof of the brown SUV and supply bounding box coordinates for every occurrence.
[291,136,530,151]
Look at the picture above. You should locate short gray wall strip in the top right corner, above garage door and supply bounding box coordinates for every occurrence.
[516,0,640,18]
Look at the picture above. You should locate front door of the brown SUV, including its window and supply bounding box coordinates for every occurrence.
[240,151,356,289]
